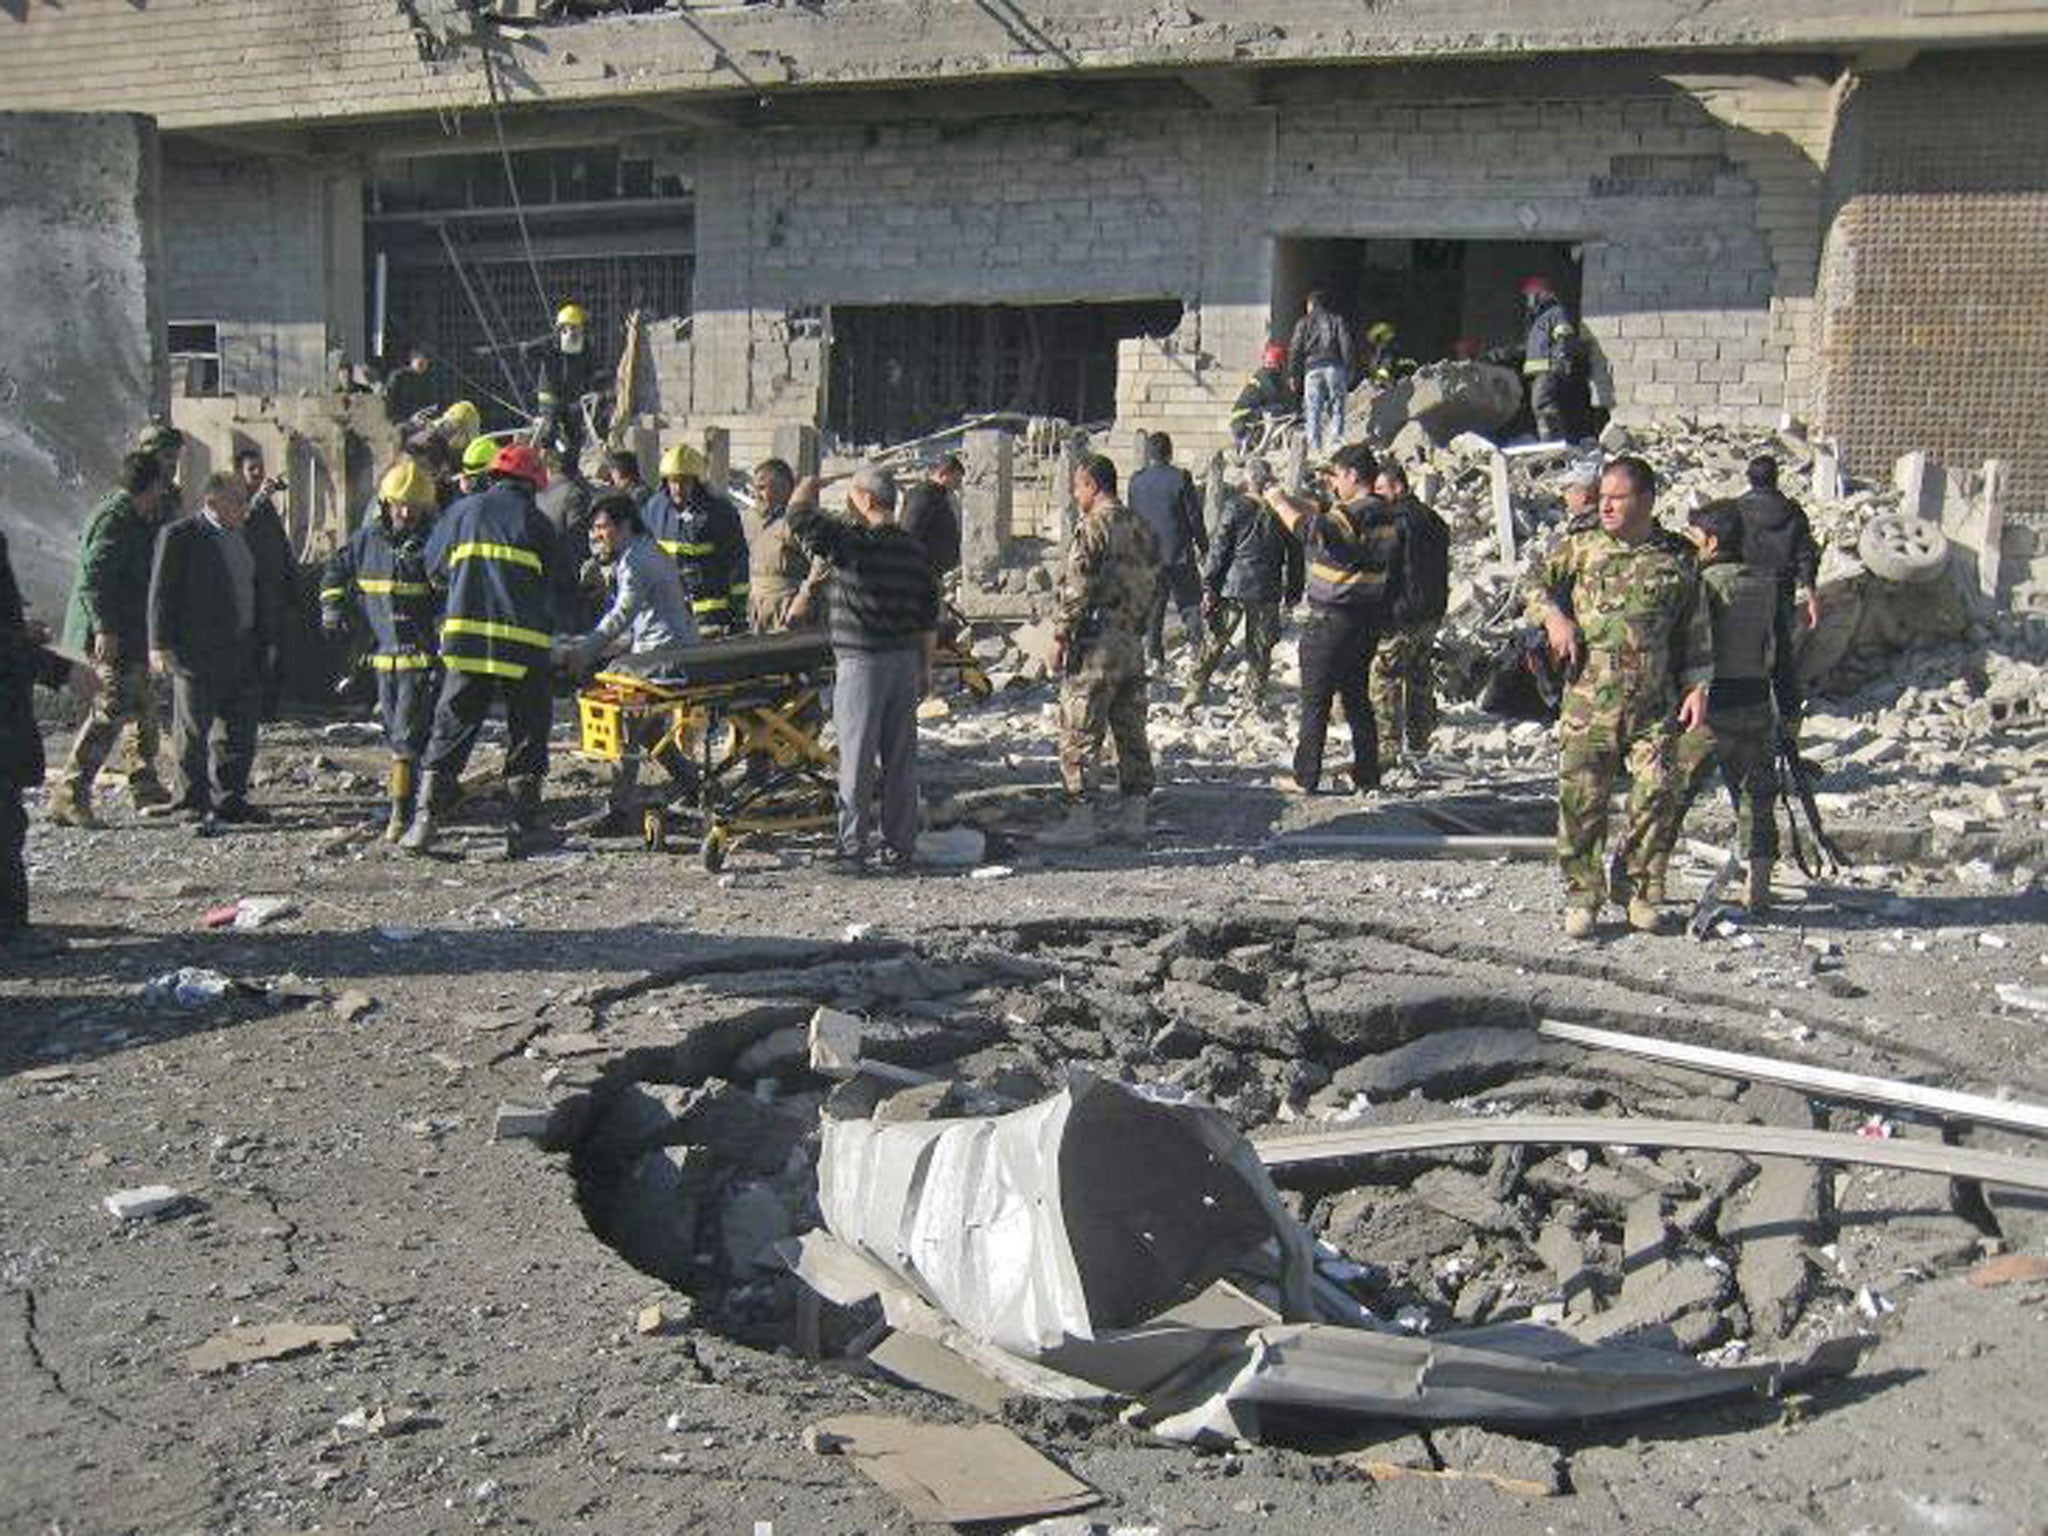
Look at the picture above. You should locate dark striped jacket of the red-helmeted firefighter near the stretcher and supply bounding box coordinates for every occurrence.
[426,479,555,680]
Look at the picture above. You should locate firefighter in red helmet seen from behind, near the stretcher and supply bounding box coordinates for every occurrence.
[399,442,559,858]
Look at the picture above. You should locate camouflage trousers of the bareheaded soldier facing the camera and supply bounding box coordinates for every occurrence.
[1556,684,1679,907]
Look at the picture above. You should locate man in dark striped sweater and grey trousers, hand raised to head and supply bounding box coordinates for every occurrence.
[786,465,938,870]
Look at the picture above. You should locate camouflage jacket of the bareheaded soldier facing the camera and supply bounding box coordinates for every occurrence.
[1528,526,1714,707]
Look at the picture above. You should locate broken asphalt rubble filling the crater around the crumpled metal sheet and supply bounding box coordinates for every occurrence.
[549,922,2031,1458]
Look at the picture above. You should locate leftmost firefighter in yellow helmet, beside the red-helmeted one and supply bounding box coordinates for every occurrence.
[319,459,440,842]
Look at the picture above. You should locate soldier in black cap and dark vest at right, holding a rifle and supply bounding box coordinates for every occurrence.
[1657,502,1778,911]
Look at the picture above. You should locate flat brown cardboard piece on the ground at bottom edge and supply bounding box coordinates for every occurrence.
[813,1413,1102,1526]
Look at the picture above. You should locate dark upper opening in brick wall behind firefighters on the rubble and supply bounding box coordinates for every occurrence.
[1270,236,1581,372]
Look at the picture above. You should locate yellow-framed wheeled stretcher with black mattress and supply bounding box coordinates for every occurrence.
[575,631,838,872]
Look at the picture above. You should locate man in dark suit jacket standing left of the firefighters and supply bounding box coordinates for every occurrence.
[150,473,285,823]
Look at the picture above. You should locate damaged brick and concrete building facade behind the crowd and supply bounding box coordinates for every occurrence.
[0,0,2048,593]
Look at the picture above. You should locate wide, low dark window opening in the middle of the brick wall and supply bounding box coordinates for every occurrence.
[825,299,1182,442]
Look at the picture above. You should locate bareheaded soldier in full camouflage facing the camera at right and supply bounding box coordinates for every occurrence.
[1528,455,1714,938]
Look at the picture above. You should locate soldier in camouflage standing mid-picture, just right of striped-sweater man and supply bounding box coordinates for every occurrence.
[1040,455,1159,848]
